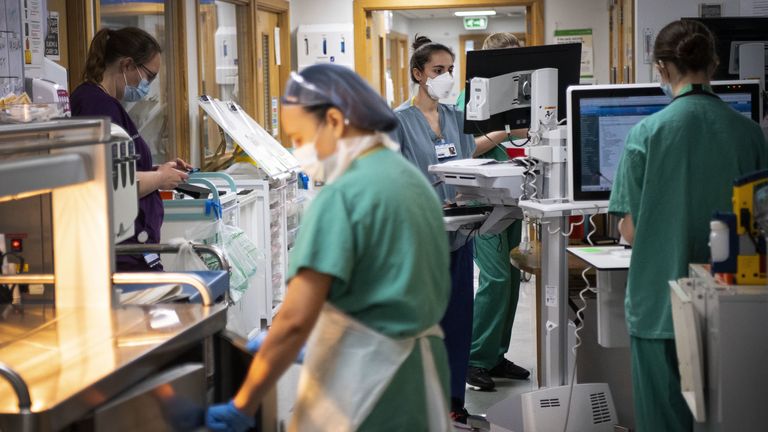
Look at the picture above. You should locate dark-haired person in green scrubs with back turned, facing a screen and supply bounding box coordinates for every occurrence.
[609,21,768,432]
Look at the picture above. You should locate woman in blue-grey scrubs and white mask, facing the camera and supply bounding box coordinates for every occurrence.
[391,36,475,423]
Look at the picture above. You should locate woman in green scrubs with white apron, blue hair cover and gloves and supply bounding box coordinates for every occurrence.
[206,64,450,432]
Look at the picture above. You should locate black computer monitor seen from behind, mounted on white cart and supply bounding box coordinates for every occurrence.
[464,43,581,135]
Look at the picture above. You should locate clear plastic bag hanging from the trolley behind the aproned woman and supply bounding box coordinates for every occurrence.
[184,219,264,302]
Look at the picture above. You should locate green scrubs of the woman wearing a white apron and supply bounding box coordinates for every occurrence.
[288,149,451,432]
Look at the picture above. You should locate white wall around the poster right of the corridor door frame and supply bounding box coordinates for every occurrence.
[544,0,608,84]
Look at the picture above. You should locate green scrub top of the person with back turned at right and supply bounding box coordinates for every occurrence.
[608,85,768,339]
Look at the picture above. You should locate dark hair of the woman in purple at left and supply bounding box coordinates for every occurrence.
[83,27,163,83]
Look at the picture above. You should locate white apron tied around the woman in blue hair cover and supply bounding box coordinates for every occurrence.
[288,303,450,432]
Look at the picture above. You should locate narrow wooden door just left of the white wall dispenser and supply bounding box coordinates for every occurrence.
[256,10,280,140]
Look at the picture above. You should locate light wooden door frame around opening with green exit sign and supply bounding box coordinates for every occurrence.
[352,0,544,82]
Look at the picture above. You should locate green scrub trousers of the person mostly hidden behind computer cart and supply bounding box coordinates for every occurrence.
[469,220,523,369]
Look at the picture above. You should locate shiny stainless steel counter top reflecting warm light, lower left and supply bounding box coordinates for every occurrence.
[0,304,226,430]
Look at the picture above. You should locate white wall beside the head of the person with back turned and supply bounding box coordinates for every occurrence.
[635,0,740,82]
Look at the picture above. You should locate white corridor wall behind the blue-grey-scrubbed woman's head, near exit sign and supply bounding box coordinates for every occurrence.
[400,17,525,103]
